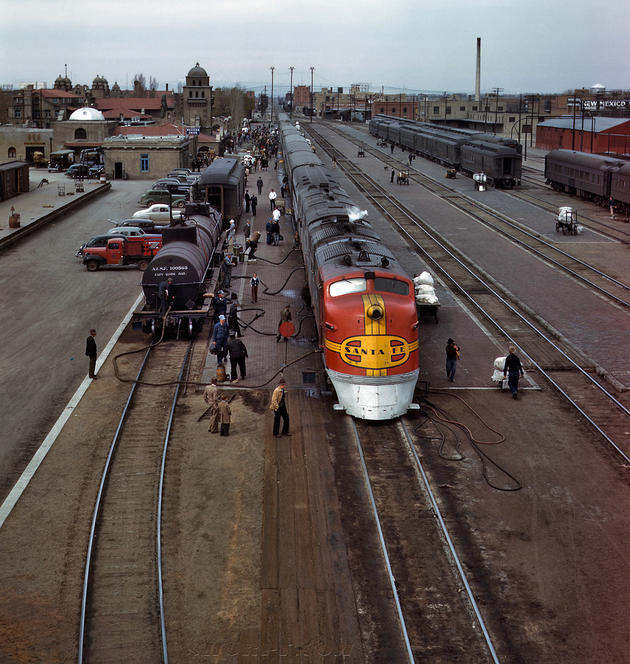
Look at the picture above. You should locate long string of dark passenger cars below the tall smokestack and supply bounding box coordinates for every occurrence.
[370,115,522,188]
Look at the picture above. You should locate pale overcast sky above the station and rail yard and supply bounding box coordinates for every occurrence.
[0,0,630,94]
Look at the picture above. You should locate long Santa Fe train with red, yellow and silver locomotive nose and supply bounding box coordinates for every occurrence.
[280,124,419,420]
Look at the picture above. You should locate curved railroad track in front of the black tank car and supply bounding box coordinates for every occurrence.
[78,342,192,664]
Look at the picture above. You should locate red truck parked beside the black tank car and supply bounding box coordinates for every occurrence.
[81,235,162,272]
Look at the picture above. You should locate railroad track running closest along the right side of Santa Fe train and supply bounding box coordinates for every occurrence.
[309,127,630,463]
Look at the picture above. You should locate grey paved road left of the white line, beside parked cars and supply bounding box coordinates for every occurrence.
[0,181,147,500]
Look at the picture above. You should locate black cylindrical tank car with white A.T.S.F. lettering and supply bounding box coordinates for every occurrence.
[133,203,222,336]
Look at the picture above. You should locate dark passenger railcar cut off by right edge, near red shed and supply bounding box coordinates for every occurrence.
[545,150,630,214]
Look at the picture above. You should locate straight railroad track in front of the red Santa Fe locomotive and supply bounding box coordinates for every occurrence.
[349,418,499,662]
